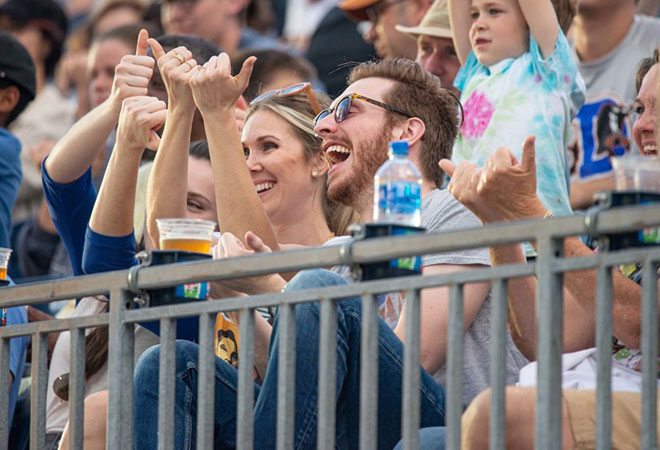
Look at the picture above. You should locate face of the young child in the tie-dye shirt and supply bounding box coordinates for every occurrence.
[470,0,529,66]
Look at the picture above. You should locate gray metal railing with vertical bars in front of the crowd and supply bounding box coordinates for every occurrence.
[0,207,660,449]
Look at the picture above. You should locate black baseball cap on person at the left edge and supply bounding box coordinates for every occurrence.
[0,31,36,100]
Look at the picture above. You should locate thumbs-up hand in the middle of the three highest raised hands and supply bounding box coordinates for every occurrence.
[148,39,197,111]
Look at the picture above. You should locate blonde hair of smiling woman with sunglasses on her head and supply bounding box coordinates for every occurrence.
[245,93,360,236]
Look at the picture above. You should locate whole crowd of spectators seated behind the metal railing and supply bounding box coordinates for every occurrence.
[0,0,660,450]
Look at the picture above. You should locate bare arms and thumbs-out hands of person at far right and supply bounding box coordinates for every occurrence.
[440,137,652,357]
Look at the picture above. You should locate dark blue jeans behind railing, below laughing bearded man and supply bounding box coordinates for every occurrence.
[134,269,444,449]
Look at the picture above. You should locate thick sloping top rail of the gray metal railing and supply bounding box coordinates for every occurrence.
[0,206,660,307]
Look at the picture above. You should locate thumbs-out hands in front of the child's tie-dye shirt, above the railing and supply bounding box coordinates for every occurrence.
[440,136,547,223]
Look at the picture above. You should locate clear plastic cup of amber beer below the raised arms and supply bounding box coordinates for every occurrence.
[156,219,215,253]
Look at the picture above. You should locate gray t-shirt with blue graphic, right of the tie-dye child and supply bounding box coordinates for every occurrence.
[569,16,660,181]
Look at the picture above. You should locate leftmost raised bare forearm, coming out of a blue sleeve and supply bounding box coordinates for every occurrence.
[45,101,119,183]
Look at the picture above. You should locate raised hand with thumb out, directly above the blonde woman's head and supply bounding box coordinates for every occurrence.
[190,53,256,115]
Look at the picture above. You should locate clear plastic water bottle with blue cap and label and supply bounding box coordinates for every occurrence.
[374,141,422,227]
